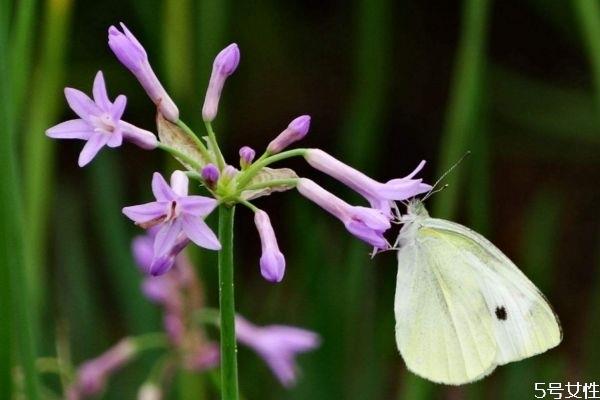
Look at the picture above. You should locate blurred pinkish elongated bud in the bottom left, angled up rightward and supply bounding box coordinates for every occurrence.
[69,339,136,398]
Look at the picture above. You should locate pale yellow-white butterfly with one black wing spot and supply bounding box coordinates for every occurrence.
[394,200,562,385]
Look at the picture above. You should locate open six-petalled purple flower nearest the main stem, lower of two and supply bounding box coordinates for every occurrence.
[123,171,221,275]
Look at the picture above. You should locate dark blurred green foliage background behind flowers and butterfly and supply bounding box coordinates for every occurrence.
[0,0,600,400]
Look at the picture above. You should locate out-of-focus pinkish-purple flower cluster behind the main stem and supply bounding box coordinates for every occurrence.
[67,238,320,400]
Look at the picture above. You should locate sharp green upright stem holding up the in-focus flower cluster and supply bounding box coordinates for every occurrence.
[219,204,239,400]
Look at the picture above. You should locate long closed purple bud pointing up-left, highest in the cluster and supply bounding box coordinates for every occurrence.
[108,23,179,122]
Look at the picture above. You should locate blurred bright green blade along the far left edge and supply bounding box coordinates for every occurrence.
[0,1,40,400]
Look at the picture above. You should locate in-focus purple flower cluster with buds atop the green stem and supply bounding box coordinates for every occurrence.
[47,24,431,282]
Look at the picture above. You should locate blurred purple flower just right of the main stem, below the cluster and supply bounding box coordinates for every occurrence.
[235,315,320,387]
